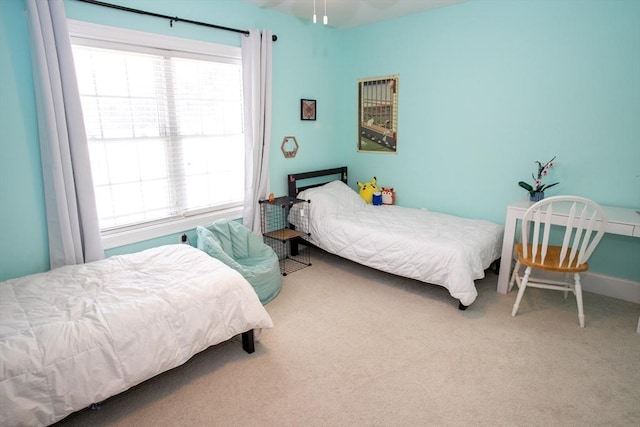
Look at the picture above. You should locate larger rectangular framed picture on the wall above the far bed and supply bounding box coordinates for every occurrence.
[358,75,400,153]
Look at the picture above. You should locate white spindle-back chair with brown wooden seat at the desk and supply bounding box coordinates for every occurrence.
[509,196,608,328]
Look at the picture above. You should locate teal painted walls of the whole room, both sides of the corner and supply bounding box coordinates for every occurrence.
[0,0,640,281]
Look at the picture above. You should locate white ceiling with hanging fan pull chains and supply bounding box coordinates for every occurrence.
[242,0,466,28]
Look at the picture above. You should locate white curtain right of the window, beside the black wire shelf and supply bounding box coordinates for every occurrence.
[242,29,273,235]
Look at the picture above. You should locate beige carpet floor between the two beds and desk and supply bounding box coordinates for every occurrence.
[58,250,640,427]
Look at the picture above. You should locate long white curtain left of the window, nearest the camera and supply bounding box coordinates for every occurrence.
[26,0,104,268]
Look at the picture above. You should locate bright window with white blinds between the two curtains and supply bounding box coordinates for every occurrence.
[70,22,244,247]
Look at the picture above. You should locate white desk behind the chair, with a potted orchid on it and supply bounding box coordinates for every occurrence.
[498,199,640,296]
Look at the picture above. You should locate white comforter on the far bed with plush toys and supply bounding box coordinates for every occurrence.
[290,181,504,305]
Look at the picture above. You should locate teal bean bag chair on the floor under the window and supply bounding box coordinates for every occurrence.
[196,220,282,304]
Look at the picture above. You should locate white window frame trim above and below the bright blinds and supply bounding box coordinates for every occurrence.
[67,19,246,249]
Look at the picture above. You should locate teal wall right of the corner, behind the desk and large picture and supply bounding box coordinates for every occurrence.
[340,0,640,281]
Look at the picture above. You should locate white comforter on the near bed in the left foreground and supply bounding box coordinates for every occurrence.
[0,245,272,426]
